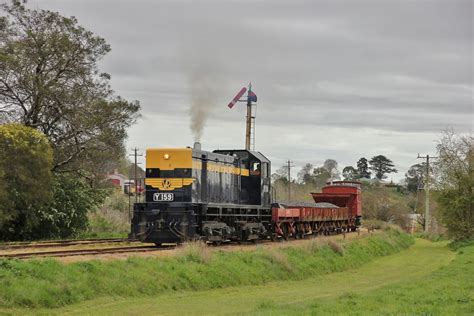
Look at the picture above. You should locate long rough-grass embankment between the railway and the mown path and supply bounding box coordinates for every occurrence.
[0,229,413,311]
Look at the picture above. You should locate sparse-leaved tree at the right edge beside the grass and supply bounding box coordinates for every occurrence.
[435,131,474,240]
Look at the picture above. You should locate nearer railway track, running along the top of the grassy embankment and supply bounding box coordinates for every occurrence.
[0,246,173,259]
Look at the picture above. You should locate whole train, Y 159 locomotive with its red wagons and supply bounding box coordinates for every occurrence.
[131,143,361,245]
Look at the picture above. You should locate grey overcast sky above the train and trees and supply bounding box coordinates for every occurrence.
[21,0,474,181]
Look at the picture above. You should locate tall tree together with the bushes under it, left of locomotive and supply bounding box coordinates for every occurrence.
[0,1,140,240]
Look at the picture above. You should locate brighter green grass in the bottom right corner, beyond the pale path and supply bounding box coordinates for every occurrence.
[253,241,474,315]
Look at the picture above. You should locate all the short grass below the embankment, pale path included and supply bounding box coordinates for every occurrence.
[1,239,458,315]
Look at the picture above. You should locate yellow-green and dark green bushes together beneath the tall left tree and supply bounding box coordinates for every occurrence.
[0,124,110,240]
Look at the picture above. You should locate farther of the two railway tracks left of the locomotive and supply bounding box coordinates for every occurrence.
[0,238,136,250]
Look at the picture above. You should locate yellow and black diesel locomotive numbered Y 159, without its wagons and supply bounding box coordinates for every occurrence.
[132,143,273,245]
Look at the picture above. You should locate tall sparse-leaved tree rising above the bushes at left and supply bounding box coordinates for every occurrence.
[0,2,140,178]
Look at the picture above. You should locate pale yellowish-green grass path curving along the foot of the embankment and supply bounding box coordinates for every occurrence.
[29,240,455,315]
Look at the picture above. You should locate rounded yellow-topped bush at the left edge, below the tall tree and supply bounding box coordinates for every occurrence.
[0,124,53,240]
